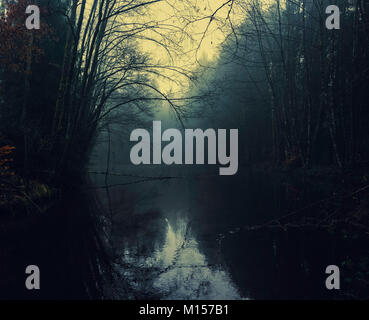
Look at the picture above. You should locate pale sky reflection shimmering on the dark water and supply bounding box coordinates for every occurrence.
[118,218,242,299]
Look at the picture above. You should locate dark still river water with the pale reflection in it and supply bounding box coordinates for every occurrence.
[90,166,365,299]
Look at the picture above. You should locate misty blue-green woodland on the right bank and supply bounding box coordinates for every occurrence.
[193,1,369,168]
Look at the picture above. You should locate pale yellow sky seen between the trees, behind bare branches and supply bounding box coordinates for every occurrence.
[85,0,274,97]
